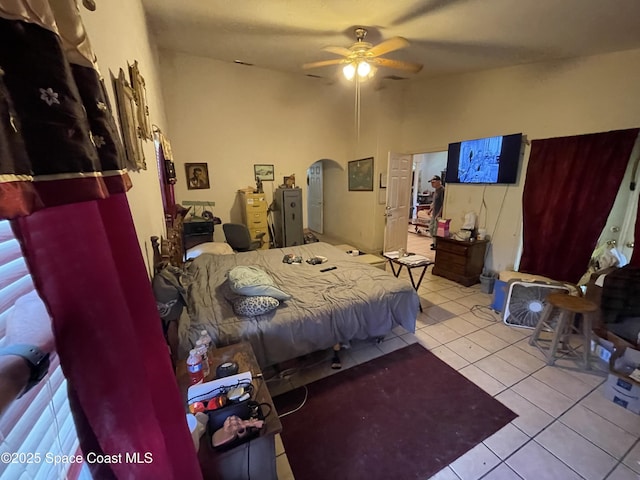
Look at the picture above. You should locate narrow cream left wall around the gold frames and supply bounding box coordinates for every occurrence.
[81,0,166,274]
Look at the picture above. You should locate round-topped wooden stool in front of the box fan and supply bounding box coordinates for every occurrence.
[529,293,598,370]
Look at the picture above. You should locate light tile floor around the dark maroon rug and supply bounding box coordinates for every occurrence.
[269,234,640,480]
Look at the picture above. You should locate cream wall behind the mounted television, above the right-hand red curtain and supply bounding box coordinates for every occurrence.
[401,50,640,270]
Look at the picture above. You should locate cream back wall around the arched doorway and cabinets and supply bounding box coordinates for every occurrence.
[156,51,373,241]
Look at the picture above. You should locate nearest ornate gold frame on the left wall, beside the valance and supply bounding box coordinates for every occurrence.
[111,68,147,172]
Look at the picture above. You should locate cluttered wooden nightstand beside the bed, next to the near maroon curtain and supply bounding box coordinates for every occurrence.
[176,342,282,480]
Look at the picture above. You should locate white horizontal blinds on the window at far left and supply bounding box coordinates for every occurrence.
[0,221,78,480]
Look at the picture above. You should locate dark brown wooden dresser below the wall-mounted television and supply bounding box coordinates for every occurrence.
[432,237,489,287]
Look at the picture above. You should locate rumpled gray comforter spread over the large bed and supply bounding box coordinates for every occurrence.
[180,243,419,368]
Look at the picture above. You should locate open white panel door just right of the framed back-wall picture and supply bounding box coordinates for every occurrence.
[384,152,413,252]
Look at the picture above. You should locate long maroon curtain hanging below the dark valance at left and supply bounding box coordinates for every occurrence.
[14,194,201,480]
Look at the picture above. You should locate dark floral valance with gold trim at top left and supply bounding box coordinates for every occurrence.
[0,0,131,219]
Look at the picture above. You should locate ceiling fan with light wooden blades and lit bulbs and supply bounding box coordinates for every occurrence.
[302,27,422,80]
